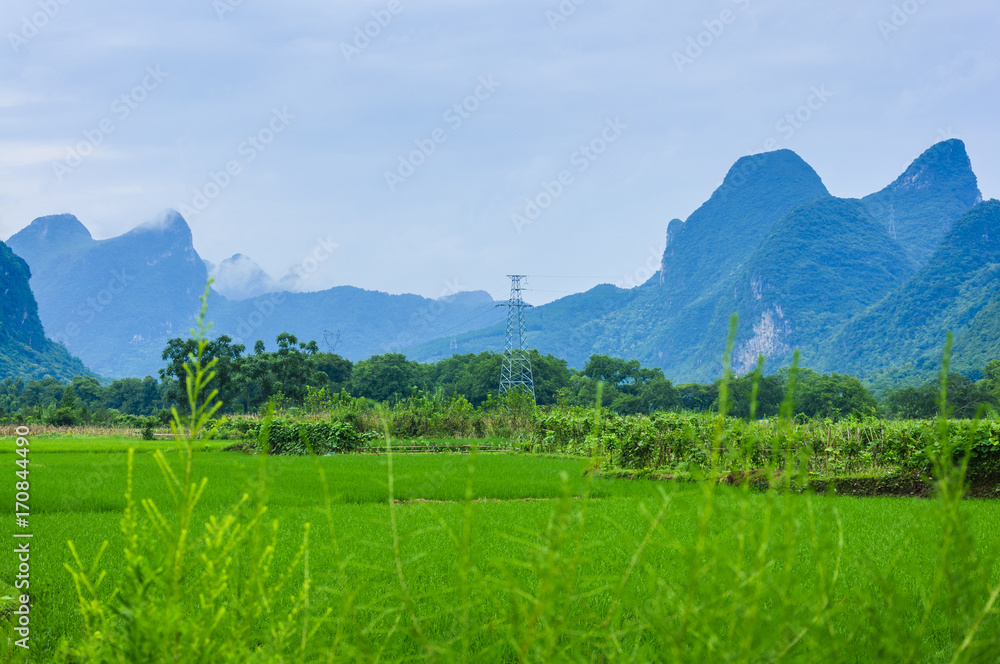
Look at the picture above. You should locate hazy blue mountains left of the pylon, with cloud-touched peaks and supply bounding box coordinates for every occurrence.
[9,210,504,378]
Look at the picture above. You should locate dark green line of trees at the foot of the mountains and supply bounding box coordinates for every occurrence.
[0,333,1000,426]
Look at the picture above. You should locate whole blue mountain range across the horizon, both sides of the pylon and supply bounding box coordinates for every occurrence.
[3,140,1000,381]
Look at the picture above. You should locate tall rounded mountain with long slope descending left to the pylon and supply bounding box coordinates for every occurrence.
[410,150,830,377]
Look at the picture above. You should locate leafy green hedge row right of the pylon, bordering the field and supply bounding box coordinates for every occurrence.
[525,411,1000,473]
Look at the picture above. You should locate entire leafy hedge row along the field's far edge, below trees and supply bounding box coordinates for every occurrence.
[223,407,1000,474]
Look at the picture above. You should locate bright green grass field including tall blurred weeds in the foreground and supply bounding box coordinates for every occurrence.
[0,310,1000,662]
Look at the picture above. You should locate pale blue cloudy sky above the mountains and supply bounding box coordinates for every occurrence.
[0,0,1000,304]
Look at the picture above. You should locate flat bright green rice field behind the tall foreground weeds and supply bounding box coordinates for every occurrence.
[0,437,1000,662]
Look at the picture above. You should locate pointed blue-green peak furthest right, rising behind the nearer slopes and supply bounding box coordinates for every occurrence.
[864,139,983,268]
